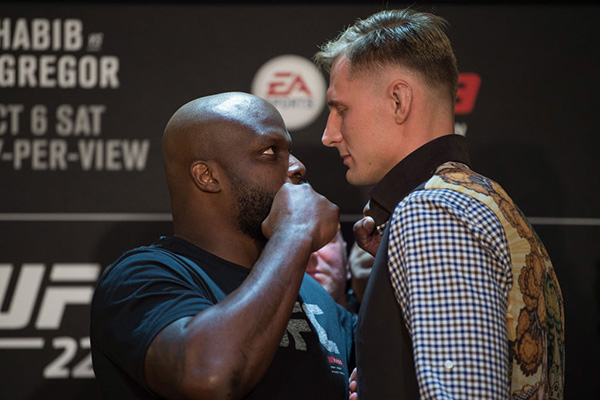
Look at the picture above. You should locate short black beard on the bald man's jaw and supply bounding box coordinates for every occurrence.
[229,173,275,246]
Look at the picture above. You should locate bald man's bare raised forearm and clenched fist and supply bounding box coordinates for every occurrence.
[145,184,338,399]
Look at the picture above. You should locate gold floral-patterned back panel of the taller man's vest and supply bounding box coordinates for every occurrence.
[425,163,565,399]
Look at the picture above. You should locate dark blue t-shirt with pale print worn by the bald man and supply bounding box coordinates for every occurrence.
[91,237,356,400]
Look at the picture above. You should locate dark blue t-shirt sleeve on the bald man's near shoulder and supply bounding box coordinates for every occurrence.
[91,248,215,390]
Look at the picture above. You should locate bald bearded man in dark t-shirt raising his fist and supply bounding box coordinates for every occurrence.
[91,93,353,399]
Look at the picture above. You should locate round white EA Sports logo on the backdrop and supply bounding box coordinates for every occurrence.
[252,55,326,131]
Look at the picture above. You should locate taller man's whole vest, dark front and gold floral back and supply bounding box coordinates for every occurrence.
[356,162,565,400]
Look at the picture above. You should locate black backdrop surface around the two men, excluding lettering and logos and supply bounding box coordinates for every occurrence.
[0,1,600,399]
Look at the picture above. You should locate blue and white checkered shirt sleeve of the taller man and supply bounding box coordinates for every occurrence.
[388,189,512,400]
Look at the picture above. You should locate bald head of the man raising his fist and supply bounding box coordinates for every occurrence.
[162,92,304,241]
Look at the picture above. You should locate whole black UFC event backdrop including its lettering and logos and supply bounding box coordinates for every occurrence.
[0,1,600,400]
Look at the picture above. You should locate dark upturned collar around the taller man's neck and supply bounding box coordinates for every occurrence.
[369,134,470,230]
